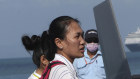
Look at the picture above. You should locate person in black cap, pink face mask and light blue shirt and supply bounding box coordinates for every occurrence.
[73,29,106,79]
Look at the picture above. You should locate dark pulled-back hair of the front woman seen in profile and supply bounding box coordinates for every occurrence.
[49,16,79,57]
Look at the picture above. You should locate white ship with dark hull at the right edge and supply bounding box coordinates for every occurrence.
[125,27,140,52]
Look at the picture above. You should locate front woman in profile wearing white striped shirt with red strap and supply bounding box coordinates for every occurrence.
[41,16,85,79]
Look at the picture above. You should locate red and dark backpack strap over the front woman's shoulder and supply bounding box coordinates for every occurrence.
[40,61,65,79]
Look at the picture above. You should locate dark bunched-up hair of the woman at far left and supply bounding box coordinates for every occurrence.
[22,31,51,67]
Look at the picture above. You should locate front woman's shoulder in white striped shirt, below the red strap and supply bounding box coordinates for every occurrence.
[49,65,74,79]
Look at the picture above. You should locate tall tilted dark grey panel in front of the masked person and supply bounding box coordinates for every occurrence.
[93,0,131,79]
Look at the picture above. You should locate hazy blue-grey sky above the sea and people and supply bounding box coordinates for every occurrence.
[0,0,140,59]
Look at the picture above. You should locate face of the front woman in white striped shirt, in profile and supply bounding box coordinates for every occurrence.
[62,21,85,59]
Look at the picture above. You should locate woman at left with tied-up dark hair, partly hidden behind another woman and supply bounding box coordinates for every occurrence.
[22,31,52,79]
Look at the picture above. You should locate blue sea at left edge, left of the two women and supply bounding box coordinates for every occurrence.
[0,58,36,79]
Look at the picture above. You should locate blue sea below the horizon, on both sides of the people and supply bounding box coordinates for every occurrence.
[0,52,140,79]
